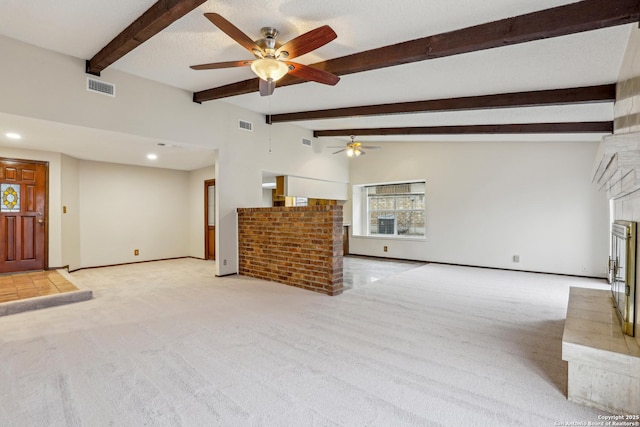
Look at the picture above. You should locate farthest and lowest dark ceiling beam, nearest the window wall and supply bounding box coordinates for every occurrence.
[313,122,613,138]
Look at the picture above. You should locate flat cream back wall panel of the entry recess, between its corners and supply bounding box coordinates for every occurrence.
[79,161,191,267]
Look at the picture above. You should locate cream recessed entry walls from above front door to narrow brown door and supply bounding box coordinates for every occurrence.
[0,147,214,270]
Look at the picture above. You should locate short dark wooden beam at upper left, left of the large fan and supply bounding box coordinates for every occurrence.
[86,0,207,76]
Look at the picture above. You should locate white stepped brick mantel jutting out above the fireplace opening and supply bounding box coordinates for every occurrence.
[593,132,640,199]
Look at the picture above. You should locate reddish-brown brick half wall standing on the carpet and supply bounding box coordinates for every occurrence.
[238,206,343,295]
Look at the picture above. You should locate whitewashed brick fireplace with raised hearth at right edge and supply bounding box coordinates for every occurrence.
[562,133,640,414]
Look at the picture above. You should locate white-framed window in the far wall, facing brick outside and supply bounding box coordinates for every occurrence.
[353,181,425,238]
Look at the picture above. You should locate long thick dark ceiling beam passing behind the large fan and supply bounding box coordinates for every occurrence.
[193,0,640,102]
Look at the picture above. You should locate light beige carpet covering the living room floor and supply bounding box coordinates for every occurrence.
[0,259,604,427]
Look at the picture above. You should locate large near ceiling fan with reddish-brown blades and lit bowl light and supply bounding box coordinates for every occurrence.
[190,13,340,96]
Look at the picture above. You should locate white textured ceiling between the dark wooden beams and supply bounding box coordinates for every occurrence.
[0,0,631,167]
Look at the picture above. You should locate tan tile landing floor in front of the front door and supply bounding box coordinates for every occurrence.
[0,270,78,303]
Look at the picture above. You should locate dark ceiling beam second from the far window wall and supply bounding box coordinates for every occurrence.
[267,84,616,123]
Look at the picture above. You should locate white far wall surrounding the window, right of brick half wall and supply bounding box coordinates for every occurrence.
[345,142,608,277]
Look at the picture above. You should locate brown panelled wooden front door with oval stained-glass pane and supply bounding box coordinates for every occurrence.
[0,159,48,273]
